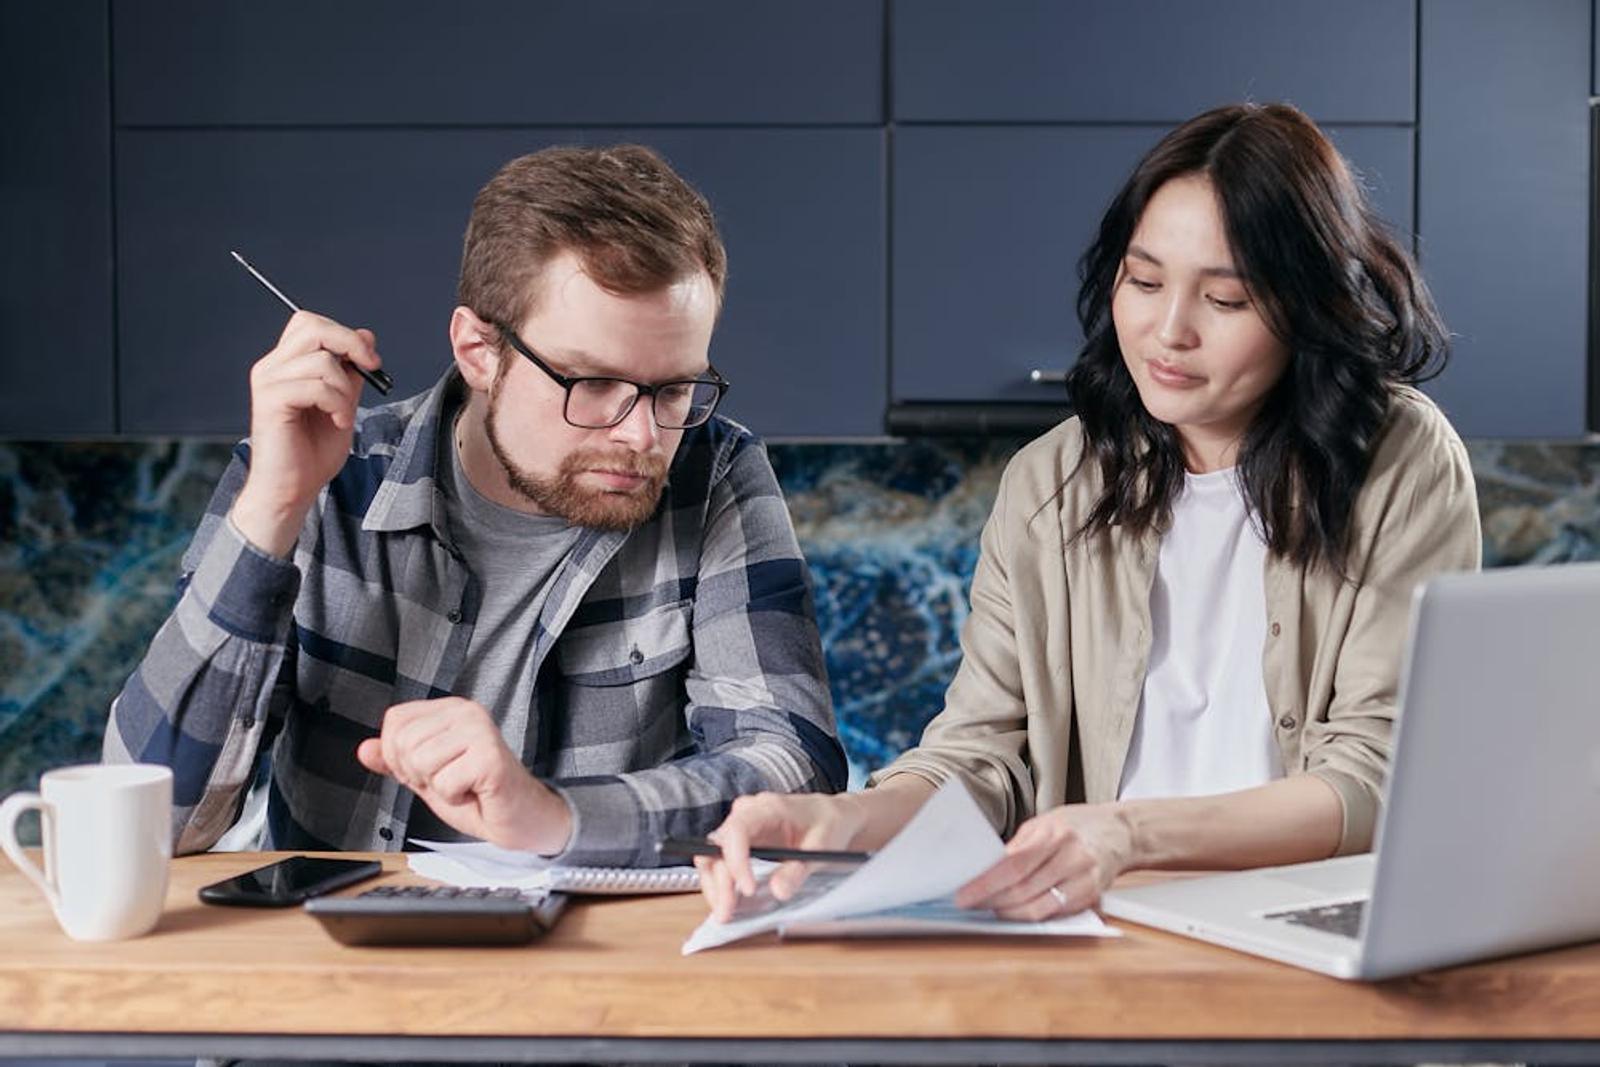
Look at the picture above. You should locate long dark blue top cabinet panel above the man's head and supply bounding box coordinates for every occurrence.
[114,0,883,125]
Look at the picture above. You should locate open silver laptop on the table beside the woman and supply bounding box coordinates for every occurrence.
[1101,563,1600,979]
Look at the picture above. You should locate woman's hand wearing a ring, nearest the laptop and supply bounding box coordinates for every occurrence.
[955,805,1133,921]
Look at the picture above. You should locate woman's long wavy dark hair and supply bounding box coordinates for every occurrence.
[1067,104,1448,569]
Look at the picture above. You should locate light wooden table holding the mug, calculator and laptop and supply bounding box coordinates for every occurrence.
[0,853,1600,1064]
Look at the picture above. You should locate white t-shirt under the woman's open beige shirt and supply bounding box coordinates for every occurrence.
[1117,469,1283,798]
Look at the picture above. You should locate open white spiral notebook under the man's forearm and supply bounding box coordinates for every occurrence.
[406,838,761,894]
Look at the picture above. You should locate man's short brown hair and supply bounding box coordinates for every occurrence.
[456,144,728,330]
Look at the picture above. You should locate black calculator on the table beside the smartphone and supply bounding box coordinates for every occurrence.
[306,886,566,945]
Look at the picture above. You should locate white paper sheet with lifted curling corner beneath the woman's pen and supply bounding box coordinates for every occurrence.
[683,779,1110,955]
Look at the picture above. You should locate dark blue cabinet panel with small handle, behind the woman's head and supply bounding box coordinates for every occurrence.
[893,126,1413,402]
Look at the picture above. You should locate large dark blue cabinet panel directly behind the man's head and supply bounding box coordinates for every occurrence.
[117,130,885,437]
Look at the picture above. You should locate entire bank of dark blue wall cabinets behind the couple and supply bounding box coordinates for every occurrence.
[0,0,1600,437]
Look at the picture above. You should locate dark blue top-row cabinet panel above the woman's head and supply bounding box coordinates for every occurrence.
[890,0,1416,123]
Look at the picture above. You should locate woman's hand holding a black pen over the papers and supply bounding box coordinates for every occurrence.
[694,793,867,923]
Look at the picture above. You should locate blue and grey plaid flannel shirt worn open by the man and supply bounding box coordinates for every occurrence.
[104,371,845,865]
